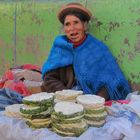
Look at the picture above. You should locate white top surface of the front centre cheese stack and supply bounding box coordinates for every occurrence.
[54,101,83,115]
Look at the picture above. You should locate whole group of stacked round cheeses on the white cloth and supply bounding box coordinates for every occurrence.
[5,90,107,137]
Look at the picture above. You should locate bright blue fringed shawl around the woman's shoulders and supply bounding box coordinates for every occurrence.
[42,34,130,100]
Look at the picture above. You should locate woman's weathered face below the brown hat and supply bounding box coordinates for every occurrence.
[64,15,86,43]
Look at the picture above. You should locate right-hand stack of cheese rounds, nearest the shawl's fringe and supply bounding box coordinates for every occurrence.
[76,95,107,127]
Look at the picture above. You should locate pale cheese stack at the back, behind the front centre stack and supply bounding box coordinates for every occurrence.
[55,90,83,103]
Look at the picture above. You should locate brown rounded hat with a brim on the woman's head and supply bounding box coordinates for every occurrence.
[57,2,92,24]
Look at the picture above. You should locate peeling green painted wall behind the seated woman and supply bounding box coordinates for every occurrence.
[0,0,140,89]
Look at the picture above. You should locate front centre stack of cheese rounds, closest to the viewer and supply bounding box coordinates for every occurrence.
[51,101,88,136]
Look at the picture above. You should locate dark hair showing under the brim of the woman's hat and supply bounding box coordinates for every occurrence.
[62,10,88,24]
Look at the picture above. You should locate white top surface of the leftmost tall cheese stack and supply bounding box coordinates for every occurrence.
[23,92,53,101]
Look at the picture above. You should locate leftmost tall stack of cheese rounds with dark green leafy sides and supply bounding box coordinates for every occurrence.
[20,92,54,128]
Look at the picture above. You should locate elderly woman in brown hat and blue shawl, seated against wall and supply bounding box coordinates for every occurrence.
[42,3,130,100]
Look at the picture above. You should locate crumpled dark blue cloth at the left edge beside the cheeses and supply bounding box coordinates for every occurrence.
[0,88,23,111]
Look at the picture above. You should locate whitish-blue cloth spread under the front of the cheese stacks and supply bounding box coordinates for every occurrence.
[0,113,140,140]
